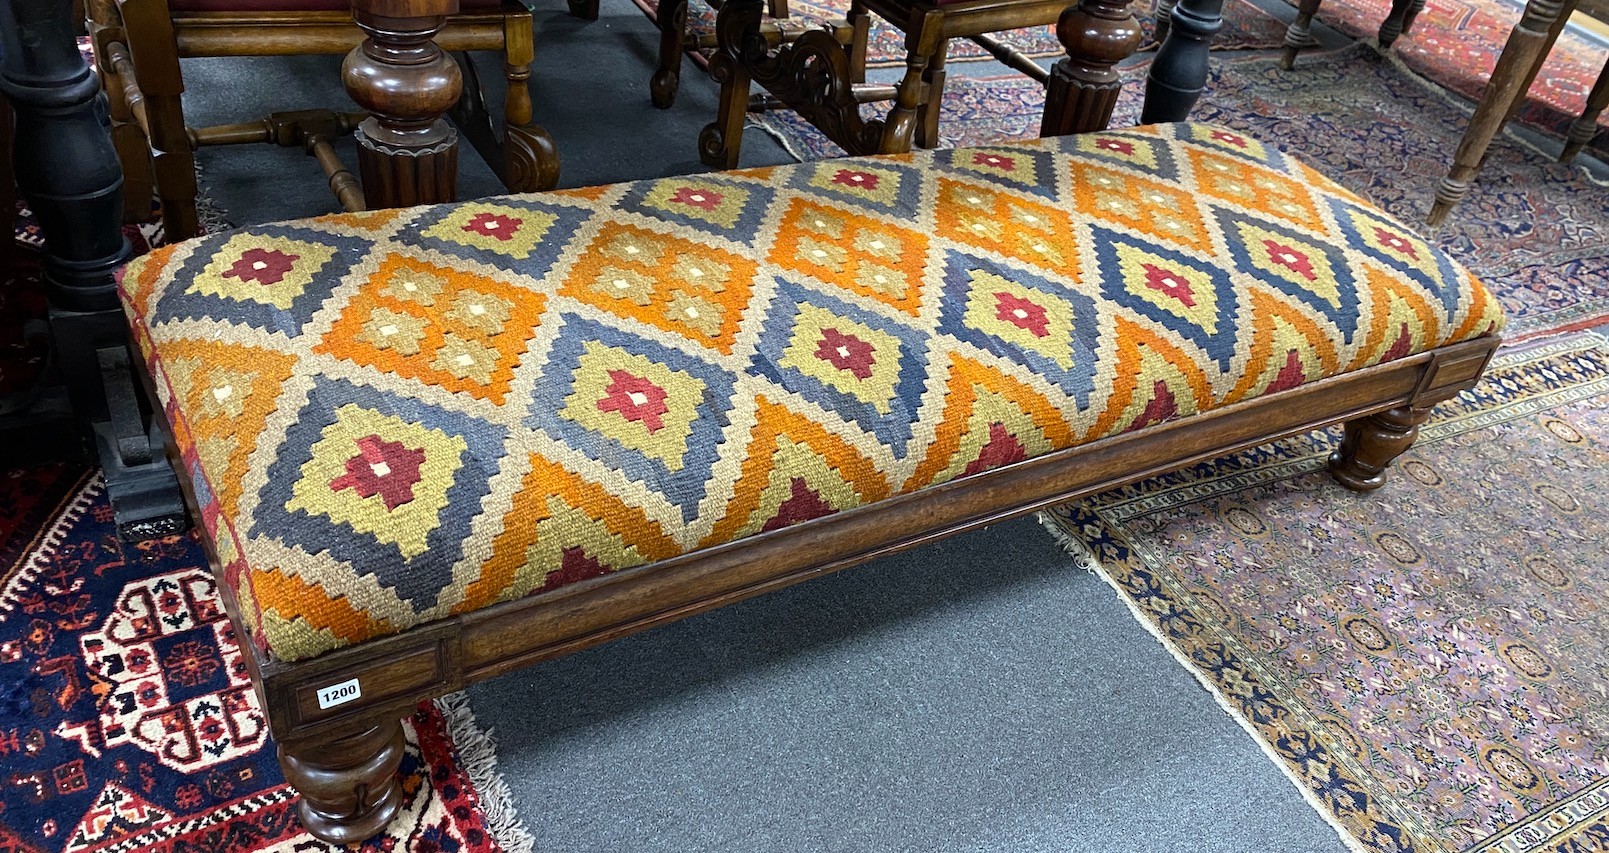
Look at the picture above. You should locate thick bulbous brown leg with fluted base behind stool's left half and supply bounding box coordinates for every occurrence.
[341,0,463,209]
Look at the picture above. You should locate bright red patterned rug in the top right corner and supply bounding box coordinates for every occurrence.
[1287,0,1609,139]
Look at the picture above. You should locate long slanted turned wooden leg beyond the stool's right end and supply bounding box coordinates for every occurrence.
[1426,0,1575,225]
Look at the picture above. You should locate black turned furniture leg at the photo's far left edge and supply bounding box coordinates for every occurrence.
[0,0,183,539]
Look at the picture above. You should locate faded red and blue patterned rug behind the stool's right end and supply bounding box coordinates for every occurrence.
[753,45,1609,341]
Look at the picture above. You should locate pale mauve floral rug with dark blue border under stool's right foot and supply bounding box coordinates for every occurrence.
[1041,332,1609,853]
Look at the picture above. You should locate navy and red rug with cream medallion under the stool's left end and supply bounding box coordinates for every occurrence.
[0,468,531,853]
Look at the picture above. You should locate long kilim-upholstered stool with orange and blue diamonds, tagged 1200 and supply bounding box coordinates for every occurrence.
[122,124,1503,840]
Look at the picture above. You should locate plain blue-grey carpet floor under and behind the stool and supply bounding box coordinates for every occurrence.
[169,0,1344,853]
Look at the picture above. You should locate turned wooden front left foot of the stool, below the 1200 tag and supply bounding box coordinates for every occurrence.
[280,718,402,845]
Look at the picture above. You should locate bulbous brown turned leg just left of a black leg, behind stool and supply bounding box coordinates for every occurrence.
[1039,0,1141,137]
